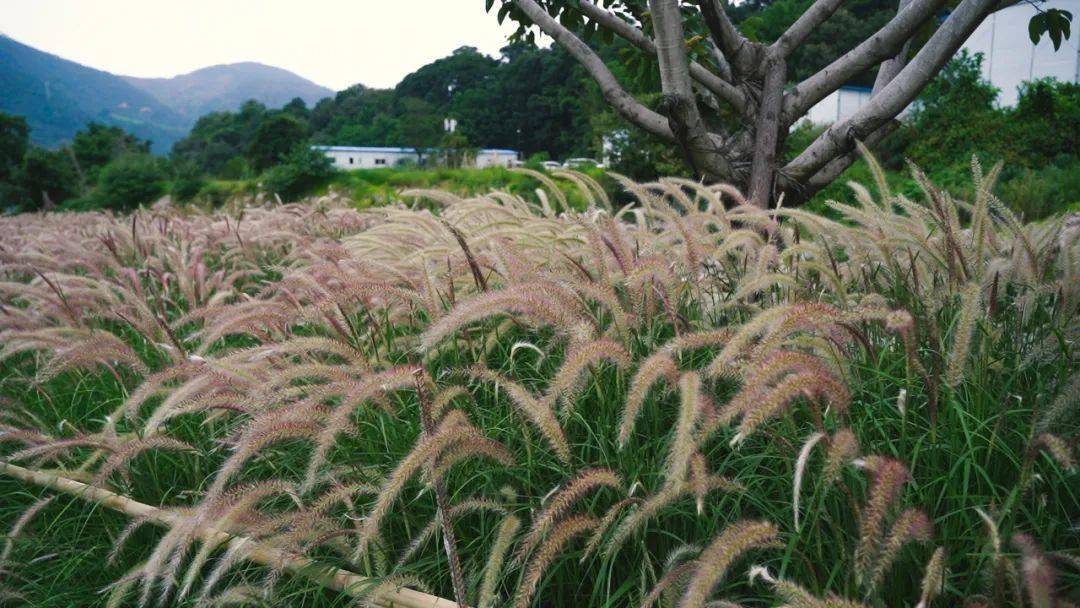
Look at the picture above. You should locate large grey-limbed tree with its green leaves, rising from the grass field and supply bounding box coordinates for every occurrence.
[487,0,1067,207]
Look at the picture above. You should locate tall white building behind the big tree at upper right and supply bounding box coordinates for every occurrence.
[807,0,1080,124]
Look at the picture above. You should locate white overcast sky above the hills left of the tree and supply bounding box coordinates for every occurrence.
[0,0,522,90]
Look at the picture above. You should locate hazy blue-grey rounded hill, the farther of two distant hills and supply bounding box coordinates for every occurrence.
[121,62,334,123]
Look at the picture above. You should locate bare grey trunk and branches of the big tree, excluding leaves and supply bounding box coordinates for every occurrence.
[504,0,1001,207]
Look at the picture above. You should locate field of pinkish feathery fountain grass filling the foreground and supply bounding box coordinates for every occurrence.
[0,163,1080,608]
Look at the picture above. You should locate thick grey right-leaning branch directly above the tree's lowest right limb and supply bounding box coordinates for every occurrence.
[784,0,945,125]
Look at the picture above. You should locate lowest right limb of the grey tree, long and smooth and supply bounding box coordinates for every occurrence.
[784,0,999,181]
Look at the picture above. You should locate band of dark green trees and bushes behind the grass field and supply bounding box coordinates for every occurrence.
[0,44,1080,219]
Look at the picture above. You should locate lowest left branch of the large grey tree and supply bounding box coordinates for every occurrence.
[514,0,675,141]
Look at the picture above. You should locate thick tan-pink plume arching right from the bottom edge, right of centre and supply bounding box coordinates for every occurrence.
[679,521,778,608]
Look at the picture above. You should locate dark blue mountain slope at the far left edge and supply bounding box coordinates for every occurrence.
[0,35,191,152]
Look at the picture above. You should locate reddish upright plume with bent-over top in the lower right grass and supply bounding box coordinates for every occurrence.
[854,456,910,584]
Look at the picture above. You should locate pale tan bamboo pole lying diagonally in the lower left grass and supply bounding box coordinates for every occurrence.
[0,461,459,608]
